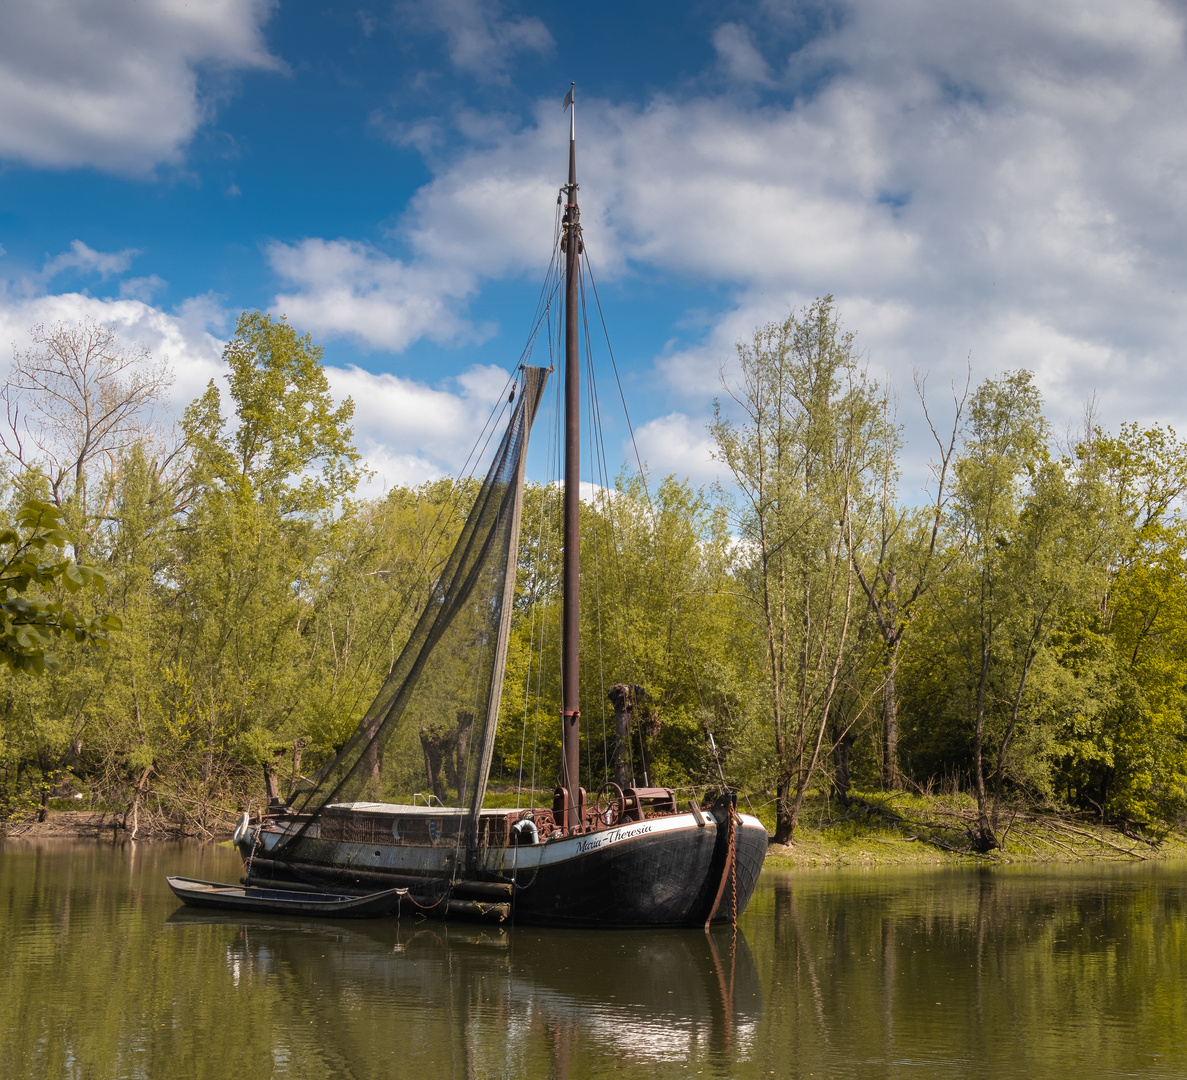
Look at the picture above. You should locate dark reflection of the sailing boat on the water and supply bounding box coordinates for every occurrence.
[170,908,762,1076]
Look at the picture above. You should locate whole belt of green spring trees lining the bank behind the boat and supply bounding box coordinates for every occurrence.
[0,308,1187,849]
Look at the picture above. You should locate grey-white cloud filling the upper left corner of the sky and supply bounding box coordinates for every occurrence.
[0,0,277,173]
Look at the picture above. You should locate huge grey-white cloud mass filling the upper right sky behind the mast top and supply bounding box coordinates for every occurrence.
[329,0,1187,491]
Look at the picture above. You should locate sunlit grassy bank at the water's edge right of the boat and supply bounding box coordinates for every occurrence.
[742,792,1187,869]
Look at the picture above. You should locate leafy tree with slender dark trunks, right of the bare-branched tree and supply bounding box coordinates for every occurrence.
[935,370,1109,851]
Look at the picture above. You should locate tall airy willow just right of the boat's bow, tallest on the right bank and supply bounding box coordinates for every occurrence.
[712,297,895,843]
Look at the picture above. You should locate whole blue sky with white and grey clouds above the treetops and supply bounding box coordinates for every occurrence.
[0,0,1187,494]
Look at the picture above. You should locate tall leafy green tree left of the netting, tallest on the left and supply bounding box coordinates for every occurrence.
[153,312,360,819]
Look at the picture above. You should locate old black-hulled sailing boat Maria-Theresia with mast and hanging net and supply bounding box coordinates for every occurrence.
[208,89,768,927]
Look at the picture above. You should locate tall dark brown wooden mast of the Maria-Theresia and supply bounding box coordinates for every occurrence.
[560,83,582,828]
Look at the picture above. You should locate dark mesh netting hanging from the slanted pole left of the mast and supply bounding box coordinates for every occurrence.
[281,367,548,860]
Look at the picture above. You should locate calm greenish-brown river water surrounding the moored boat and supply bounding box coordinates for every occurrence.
[0,840,1187,1080]
